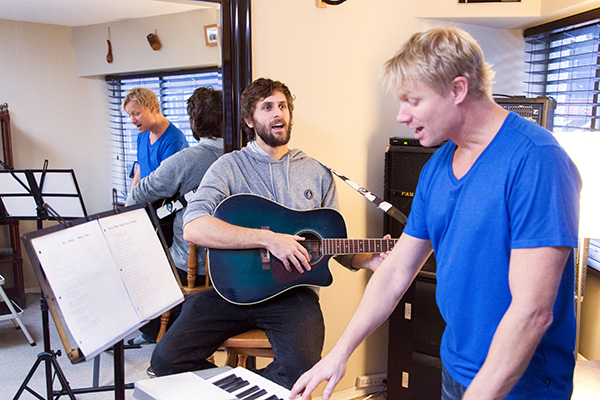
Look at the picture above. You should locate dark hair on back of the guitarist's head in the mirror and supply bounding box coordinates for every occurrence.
[187,87,223,140]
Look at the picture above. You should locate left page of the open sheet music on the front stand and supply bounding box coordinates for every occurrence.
[32,221,141,357]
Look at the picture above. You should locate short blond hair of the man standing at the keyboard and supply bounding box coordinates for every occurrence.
[381,28,494,97]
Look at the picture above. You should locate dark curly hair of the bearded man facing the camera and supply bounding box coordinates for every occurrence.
[240,78,295,141]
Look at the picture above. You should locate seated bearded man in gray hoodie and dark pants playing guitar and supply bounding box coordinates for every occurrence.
[151,78,382,388]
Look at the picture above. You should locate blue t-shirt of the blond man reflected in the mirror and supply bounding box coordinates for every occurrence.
[137,123,189,179]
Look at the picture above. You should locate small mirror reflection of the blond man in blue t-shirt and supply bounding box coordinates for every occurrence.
[123,88,189,194]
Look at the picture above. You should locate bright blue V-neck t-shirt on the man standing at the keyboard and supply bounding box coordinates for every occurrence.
[404,113,581,399]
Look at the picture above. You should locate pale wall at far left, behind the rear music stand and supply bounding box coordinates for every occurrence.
[0,20,111,289]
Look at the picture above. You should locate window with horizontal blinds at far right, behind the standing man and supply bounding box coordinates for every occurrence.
[524,9,600,132]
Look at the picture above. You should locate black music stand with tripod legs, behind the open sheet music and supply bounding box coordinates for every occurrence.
[0,167,132,400]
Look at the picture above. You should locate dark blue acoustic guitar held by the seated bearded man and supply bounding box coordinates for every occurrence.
[207,194,397,305]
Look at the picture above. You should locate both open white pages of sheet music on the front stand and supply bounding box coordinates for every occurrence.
[31,209,183,359]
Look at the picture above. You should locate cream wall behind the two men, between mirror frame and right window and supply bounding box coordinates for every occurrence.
[252,0,524,389]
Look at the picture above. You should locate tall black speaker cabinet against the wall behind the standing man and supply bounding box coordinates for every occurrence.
[384,138,445,400]
